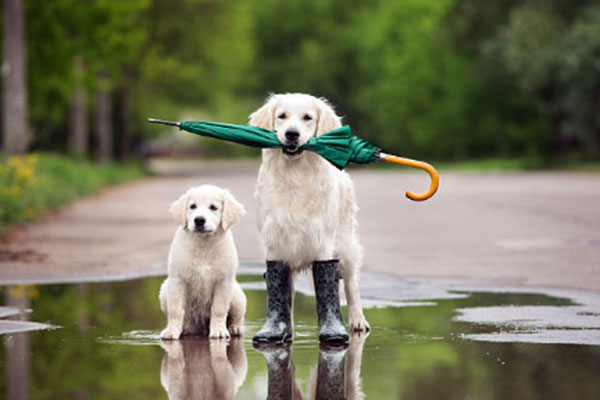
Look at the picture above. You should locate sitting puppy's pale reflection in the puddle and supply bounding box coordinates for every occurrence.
[160,339,248,400]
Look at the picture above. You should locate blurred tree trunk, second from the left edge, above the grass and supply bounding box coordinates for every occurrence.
[69,55,89,158]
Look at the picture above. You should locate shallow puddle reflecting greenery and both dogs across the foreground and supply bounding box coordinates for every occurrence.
[0,270,600,400]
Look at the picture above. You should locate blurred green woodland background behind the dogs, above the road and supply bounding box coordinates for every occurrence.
[2,0,600,166]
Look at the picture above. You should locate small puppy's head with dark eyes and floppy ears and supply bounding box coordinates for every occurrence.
[169,185,245,236]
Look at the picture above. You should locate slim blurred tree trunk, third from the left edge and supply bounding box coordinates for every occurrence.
[96,73,112,162]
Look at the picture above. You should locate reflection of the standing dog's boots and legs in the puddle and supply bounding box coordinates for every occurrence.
[255,334,368,400]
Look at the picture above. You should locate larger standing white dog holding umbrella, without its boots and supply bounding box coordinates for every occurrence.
[250,93,369,331]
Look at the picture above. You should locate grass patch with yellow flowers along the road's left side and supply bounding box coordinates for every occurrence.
[0,153,145,234]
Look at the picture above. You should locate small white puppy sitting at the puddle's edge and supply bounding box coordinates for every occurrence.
[159,185,246,339]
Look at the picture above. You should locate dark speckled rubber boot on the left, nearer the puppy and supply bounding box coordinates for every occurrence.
[252,261,292,342]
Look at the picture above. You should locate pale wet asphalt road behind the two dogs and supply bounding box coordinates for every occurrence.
[0,159,600,291]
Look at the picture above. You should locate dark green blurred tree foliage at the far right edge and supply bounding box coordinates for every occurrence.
[454,0,600,161]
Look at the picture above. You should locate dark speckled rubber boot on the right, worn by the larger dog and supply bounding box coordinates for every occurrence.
[313,260,349,343]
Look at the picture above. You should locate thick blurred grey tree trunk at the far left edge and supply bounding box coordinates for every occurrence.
[2,0,28,154]
